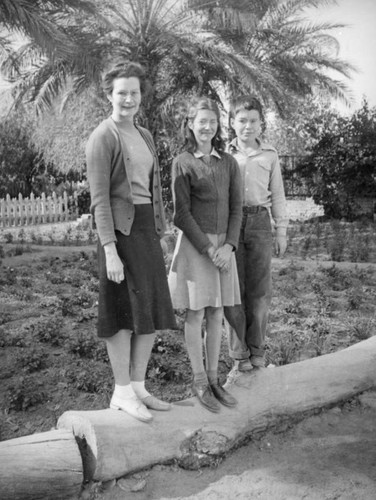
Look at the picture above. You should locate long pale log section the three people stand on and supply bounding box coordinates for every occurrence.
[58,336,376,481]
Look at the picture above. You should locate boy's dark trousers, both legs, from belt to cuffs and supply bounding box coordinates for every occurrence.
[224,207,272,359]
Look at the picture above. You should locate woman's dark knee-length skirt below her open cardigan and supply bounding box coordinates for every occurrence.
[98,204,176,337]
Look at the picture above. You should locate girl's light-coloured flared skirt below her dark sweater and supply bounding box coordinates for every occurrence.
[168,232,241,310]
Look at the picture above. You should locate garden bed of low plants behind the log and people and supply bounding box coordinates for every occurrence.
[0,221,376,440]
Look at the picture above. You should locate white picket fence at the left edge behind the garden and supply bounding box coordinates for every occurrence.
[0,192,78,227]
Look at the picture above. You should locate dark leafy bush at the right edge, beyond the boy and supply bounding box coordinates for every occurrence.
[297,101,376,220]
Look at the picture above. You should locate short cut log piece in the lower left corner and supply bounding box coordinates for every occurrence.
[0,429,83,500]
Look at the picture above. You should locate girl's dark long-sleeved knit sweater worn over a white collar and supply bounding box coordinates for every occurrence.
[172,152,242,253]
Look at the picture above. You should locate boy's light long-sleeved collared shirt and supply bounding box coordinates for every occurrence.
[228,138,288,229]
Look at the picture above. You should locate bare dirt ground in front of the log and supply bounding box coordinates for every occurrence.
[86,392,376,500]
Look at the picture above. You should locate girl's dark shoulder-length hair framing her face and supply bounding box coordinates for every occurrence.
[182,97,225,153]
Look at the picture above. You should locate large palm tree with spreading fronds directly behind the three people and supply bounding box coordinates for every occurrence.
[0,0,352,180]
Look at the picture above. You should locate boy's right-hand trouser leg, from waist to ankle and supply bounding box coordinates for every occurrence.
[244,212,272,366]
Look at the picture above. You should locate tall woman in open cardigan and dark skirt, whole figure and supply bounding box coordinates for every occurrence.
[86,63,176,422]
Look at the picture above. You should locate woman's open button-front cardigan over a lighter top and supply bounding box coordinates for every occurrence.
[86,118,166,246]
